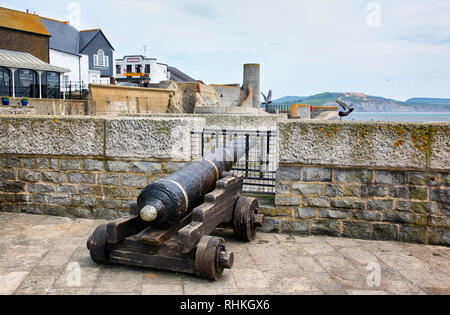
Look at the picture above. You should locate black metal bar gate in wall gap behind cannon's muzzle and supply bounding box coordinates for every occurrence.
[191,129,278,194]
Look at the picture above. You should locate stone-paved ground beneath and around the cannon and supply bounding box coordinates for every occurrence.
[0,213,450,295]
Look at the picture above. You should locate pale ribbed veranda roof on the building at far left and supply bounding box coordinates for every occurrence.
[0,49,70,73]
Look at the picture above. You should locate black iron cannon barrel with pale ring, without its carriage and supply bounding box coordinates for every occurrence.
[137,140,256,228]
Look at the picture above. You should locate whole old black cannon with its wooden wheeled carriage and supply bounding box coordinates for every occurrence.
[87,140,264,280]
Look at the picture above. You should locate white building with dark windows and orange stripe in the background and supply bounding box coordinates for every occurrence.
[115,55,170,84]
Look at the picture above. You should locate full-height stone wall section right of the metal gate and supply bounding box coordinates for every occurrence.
[265,121,450,245]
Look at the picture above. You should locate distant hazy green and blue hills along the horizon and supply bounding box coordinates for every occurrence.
[273,92,450,112]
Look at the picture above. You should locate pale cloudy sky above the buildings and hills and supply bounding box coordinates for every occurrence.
[0,0,450,100]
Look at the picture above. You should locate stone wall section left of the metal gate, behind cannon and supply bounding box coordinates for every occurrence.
[0,116,204,219]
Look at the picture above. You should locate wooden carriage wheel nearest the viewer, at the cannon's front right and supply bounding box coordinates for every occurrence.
[195,235,234,280]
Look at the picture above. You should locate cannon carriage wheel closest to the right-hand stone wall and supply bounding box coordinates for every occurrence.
[233,197,264,242]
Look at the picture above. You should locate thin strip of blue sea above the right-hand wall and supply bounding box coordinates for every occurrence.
[342,112,450,122]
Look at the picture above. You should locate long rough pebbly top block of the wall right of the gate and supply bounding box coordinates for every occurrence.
[278,120,432,169]
